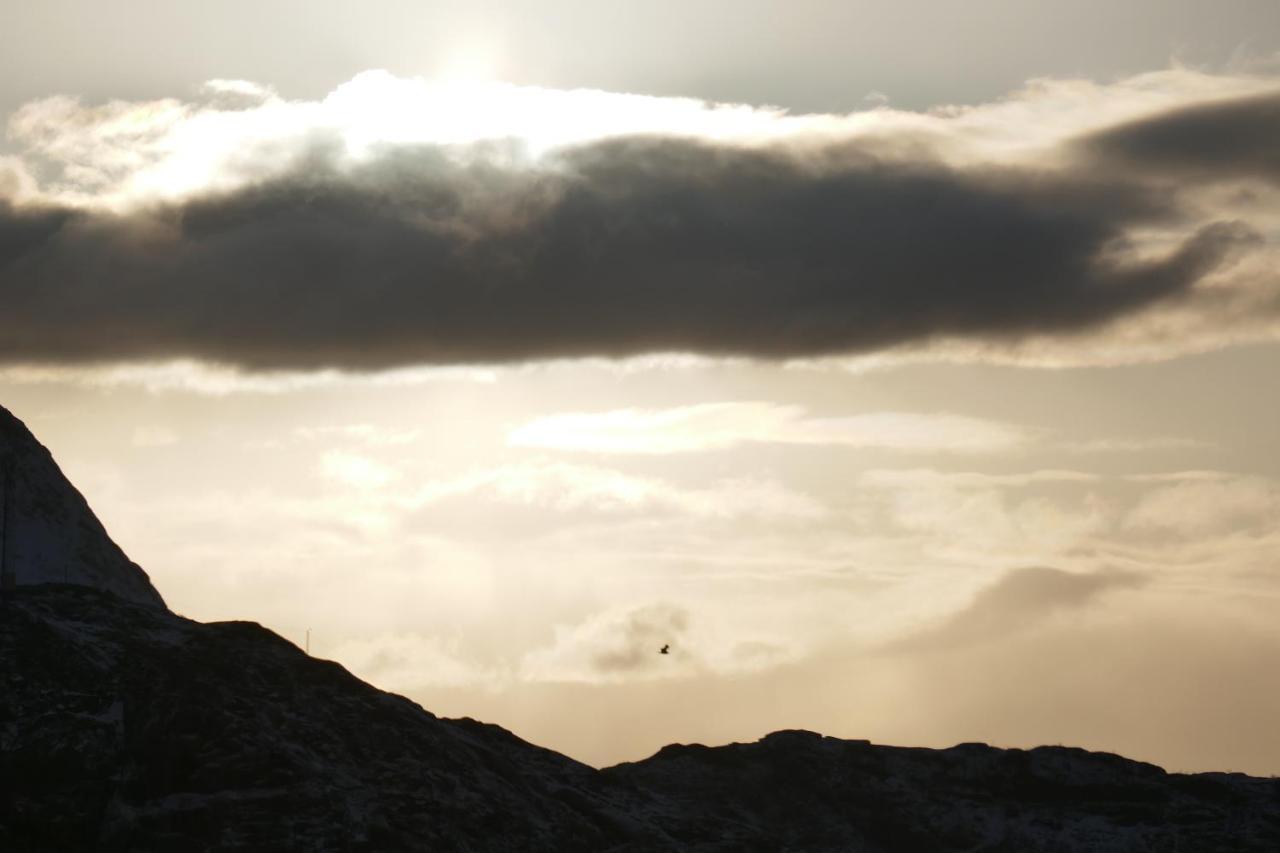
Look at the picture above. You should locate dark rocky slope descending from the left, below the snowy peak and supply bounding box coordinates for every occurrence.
[0,585,640,852]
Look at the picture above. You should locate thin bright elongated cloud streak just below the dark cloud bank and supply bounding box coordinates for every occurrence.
[507,402,1027,453]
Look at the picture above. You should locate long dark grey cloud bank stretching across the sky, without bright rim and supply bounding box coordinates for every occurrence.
[0,97,1277,370]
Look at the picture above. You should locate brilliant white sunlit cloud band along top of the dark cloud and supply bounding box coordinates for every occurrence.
[9,68,1274,206]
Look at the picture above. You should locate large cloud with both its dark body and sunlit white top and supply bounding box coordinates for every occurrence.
[0,69,1261,371]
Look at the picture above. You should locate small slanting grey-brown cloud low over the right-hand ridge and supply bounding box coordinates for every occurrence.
[886,567,1144,652]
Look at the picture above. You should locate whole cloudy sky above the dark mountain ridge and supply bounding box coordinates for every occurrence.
[0,0,1280,774]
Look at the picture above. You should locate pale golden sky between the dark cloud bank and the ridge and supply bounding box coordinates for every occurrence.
[4,340,1280,771]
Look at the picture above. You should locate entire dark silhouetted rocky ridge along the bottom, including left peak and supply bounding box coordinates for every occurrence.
[0,407,1280,853]
